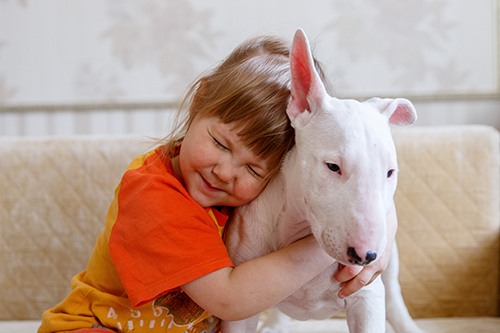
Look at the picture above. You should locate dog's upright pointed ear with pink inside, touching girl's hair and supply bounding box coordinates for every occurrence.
[287,29,326,124]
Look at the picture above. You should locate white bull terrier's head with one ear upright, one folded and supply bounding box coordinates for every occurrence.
[287,30,416,265]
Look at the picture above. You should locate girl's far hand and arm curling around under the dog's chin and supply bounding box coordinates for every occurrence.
[333,205,398,298]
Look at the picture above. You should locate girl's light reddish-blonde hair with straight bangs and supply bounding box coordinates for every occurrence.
[163,36,323,179]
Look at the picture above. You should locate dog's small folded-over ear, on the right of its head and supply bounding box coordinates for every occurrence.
[367,97,417,126]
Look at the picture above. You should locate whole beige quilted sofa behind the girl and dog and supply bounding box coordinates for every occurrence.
[0,126,500,333]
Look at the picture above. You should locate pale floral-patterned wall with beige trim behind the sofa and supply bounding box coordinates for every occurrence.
[0,0,500,136]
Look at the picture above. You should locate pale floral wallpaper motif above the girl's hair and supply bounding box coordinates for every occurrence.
[101,0,216,96]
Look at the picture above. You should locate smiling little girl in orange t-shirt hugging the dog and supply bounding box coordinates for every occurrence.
[39,32,395,333]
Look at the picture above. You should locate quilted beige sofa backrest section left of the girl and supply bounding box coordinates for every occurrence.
[0,137,152,320]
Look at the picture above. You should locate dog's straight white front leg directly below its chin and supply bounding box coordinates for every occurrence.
[345,277,385,333]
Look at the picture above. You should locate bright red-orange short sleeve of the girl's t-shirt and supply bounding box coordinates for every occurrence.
[109,161,232,306]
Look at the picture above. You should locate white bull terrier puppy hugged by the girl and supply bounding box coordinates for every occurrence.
[222,30,423,333]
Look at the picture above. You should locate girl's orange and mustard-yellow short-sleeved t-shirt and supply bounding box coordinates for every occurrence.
[38,150,232,333]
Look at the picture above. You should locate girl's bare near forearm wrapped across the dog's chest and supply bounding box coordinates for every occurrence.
[182,232,335,321]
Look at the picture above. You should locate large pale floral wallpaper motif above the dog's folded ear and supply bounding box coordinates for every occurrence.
[327,0,470,93]
